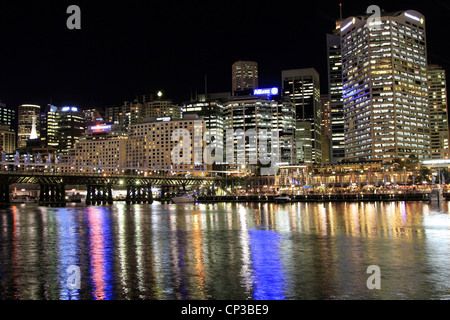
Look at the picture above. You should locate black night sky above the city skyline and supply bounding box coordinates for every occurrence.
[0,0,450,108]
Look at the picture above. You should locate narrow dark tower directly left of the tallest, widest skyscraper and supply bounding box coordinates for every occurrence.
[322,20,345,163]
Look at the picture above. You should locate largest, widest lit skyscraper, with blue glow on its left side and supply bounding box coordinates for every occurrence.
[340,10,430,161]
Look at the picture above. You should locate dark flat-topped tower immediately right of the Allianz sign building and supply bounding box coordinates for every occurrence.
[282,68,322,164]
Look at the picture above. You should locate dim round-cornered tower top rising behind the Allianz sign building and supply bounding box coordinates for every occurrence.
[231,61,259,95]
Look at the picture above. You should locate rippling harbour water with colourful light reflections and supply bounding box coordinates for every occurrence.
[0,202,450,300]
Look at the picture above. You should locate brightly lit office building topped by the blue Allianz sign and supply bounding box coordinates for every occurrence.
[224,88,295,171]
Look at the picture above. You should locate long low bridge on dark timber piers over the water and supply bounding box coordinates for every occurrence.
[0,162,223,206]
